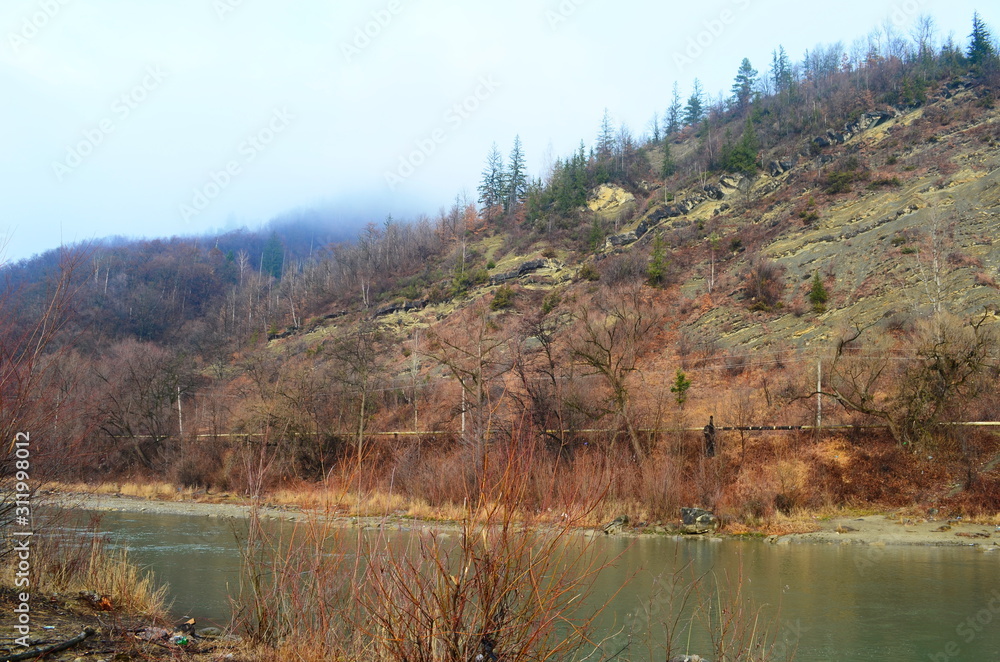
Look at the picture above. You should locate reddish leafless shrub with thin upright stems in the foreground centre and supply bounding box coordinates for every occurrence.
[236,440,624,662]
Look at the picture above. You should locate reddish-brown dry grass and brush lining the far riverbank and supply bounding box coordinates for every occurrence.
[45,426,1000,533]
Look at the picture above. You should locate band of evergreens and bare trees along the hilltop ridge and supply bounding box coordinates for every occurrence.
[479,13,1000,236]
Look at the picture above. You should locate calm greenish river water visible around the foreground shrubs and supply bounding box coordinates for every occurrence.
[56,512,1000,662]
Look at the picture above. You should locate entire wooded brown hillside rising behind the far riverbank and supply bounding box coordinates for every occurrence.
[2,28,1000,529]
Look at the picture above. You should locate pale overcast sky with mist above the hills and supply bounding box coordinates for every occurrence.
[0,0,1000,260]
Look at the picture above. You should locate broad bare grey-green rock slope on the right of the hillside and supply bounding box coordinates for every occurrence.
[584,91,1000,348]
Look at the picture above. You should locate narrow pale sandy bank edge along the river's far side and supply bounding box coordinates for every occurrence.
[44,492,1000,552]
